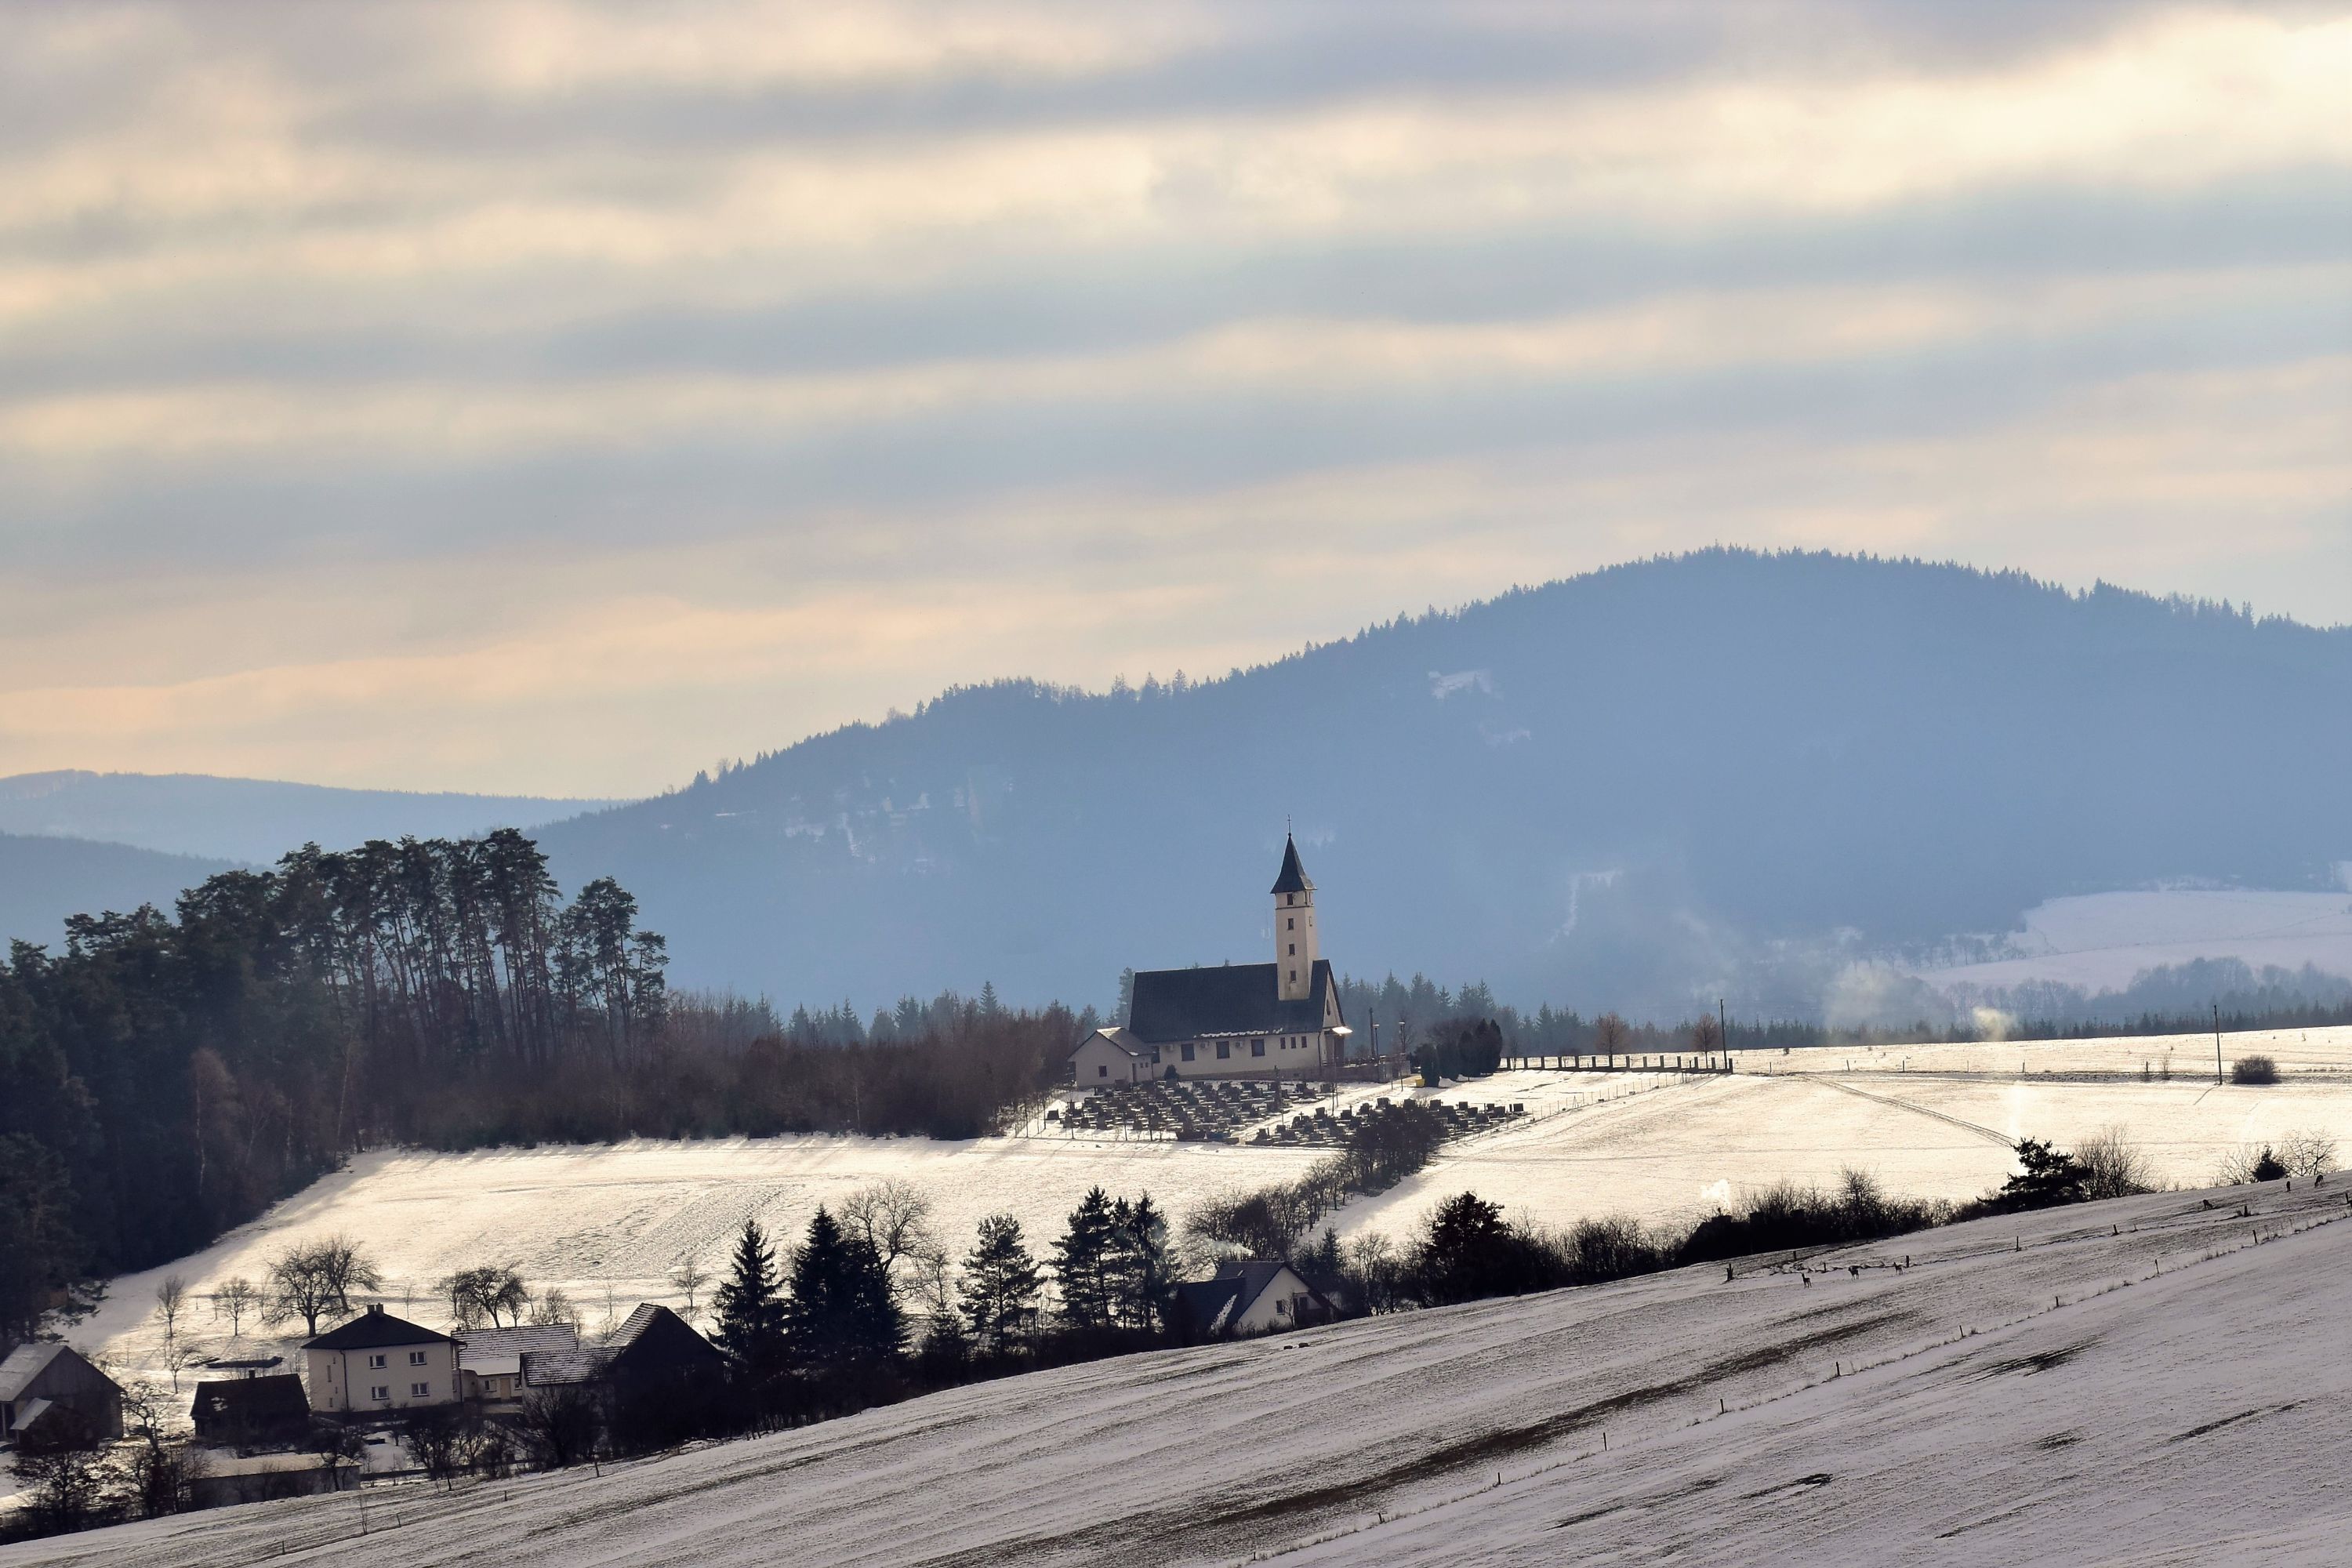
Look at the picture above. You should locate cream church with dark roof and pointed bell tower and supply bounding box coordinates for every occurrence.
[1070,837,1350,1088]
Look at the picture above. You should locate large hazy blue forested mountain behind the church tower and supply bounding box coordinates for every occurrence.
[539,553,2352,1011]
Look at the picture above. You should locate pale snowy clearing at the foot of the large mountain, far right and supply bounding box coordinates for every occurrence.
[1919,888,2352,992]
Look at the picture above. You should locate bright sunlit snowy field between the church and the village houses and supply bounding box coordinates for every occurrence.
[68,1029,2352,1380]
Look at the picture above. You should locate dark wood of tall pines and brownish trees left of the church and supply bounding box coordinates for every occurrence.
[0,829,1080,1347]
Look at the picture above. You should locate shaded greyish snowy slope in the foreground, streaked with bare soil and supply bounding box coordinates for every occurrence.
[0,1171,2352,1568]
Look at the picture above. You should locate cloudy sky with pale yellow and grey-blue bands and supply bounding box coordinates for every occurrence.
[0,0,2352,794]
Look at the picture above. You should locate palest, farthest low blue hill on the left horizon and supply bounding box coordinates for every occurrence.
[0,771,607,865]
